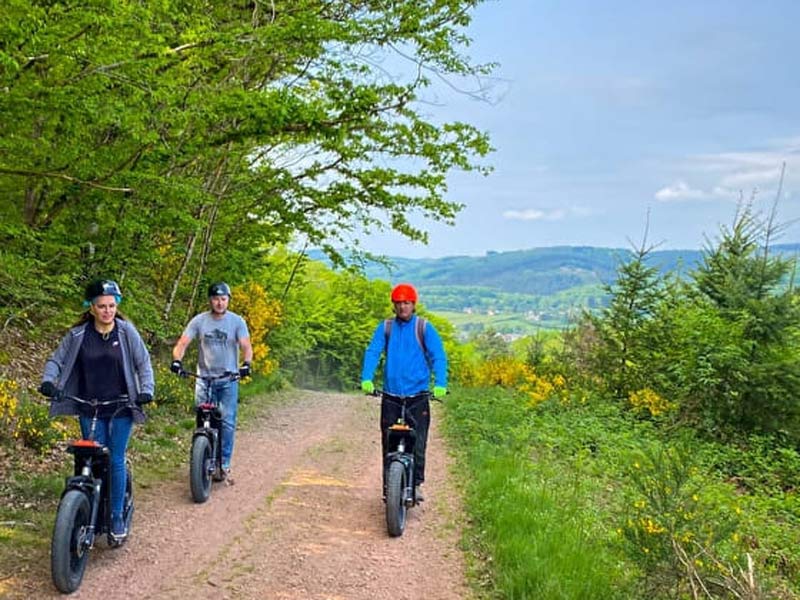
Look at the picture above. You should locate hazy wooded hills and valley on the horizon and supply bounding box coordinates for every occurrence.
[310,244,800,333]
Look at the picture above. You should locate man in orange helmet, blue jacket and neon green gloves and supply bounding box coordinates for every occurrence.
[361,283,447,500]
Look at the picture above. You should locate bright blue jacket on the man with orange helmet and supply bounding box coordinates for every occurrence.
[361,315,447,396]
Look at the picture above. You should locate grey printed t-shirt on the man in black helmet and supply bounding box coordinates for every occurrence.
[183,311,250,377]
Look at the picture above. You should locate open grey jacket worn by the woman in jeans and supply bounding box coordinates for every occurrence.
[42,318,155,423]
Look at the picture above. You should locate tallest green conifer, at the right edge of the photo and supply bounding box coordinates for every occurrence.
[690,205,800,438]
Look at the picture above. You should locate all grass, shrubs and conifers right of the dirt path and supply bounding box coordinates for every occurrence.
[444,207,800,599]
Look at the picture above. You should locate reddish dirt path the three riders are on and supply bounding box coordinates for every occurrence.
[12,392,470,600]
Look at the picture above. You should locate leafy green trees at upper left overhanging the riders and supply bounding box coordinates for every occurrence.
[0,0,490,344]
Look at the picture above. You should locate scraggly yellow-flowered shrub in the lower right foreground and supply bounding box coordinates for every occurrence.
[620,442,759,598]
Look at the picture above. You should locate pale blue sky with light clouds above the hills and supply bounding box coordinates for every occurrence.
[361,0,800,258]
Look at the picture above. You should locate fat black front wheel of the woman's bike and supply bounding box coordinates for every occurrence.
[50,490,92,594]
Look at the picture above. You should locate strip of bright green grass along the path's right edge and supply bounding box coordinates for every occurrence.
[445,390,627,600]
